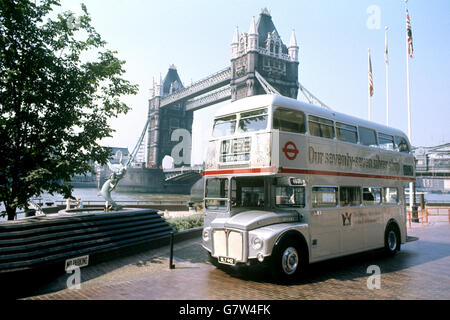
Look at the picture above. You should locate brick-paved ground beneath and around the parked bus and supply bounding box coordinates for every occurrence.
[15,217,450,300]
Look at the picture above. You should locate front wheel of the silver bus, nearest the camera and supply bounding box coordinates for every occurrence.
[271,237,307,282]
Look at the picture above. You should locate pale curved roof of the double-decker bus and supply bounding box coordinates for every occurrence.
[215,94,409,141]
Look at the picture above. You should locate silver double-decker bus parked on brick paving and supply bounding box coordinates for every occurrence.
[202,95,415,280]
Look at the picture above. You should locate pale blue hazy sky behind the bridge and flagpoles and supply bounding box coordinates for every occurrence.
[56,0,450,163]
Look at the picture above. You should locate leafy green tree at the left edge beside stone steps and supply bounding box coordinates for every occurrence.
[0,0,137,220]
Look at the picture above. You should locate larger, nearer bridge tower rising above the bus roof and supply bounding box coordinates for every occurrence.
[230,9,299,101]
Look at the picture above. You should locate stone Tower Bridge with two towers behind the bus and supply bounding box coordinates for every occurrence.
[146,9,303,174]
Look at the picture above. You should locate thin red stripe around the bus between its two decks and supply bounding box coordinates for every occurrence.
[205,168,416,181]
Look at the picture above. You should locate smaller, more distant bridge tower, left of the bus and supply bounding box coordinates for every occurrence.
[147,65,193,168]
